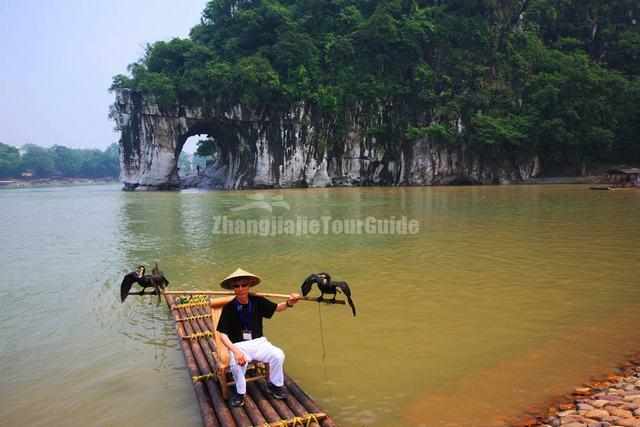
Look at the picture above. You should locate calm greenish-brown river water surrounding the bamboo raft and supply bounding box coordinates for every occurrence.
[0,186,640,426]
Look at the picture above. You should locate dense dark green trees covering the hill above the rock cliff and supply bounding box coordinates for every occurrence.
[112,0,640,173]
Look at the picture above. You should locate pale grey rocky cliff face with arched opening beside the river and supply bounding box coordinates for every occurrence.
[111,89,540,190]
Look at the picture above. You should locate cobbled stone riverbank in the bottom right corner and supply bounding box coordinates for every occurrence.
[513,351,640,427]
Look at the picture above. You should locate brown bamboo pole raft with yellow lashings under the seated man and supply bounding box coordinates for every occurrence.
[164,293,337,427]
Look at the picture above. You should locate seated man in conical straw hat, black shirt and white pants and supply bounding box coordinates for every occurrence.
[216,268,300,407]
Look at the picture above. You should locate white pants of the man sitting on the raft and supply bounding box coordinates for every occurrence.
[229,337,284,394]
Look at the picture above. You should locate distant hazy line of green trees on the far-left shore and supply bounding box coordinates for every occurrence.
[0,143,120,178]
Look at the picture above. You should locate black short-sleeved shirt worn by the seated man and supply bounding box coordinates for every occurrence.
[216,295,278,343]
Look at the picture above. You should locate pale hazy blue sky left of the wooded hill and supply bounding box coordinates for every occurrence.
[0,0,206,149]
